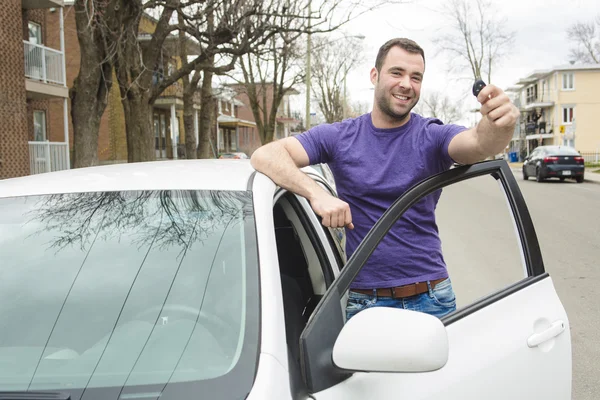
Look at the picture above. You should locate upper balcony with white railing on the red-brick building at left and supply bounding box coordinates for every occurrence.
[23,41,69,99]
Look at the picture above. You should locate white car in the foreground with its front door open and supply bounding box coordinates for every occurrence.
[0,160,571,400]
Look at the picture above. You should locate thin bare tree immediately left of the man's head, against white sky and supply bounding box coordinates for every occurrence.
[311,36,365,123]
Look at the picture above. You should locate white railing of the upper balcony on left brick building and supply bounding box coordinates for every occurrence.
[23,41,65,85]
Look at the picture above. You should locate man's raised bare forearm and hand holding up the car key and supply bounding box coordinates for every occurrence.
[448,85,519,164]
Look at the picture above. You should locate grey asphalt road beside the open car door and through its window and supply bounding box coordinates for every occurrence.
[437,173,600,400]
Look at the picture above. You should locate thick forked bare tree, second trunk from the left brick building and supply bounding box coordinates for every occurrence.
[114,0,268,162]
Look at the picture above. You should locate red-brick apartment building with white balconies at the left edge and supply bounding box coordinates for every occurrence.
[0,0,70,179]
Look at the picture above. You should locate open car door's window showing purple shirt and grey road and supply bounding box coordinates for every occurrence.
[340,176,526,311]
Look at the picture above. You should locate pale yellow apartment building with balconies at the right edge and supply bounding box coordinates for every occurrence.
[507,64,600,159]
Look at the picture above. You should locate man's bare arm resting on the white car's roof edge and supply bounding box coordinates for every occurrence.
[250,137,354,229]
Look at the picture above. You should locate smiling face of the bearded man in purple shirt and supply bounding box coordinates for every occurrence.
[371,46,425,122]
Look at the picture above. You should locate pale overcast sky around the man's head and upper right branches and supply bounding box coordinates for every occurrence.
[293,0,600,123]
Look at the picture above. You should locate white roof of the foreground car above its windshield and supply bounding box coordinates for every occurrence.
[0,159,255,197]
